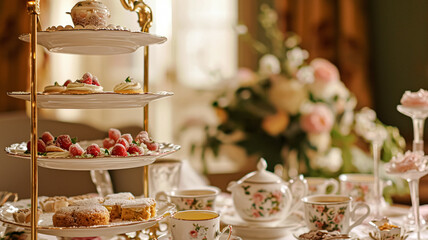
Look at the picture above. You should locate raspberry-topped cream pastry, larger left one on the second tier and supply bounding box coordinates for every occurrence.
[64,72,103,94]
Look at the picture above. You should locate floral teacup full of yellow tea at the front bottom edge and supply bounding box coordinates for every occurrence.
[170,210,232,240]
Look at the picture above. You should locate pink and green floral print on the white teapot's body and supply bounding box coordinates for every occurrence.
[242,185,285,218]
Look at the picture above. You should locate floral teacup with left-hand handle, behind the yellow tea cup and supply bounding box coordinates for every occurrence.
[156,188,220,211]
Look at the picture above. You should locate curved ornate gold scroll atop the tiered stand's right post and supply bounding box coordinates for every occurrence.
[120,0,153,32]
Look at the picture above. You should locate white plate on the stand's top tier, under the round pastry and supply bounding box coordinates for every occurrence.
[19,29,166,55]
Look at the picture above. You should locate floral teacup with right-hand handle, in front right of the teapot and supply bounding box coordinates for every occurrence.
[302,195,370,234]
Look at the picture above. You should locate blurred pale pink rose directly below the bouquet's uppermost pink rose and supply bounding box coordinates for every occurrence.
[300,103,334,133]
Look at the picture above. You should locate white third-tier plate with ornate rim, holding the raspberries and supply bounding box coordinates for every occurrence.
[5,140,181,171]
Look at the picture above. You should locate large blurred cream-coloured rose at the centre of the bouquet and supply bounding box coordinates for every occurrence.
[269,75,308,115]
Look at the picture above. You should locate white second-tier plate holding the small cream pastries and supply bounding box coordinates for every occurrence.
[7,92,174,109]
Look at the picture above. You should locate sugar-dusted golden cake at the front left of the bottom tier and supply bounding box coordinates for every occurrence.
[52,205,110,227]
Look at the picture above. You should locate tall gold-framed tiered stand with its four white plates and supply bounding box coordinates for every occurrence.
[0,0,179,240]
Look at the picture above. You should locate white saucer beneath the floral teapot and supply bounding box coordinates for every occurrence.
[221,213,305,239]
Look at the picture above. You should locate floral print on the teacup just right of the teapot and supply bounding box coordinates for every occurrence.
[309,204,347,231]
